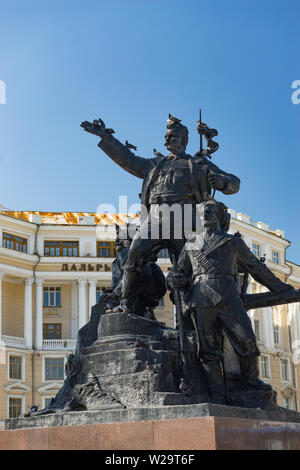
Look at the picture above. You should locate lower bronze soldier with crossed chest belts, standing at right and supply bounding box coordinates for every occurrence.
[167,199,292,404]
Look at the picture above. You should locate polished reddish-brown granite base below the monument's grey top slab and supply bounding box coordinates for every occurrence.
[0,416,300,450]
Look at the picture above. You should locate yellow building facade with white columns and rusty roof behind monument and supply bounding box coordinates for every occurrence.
[0,210,300,424]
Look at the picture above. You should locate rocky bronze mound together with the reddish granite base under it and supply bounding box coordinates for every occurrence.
[4,314,300,450]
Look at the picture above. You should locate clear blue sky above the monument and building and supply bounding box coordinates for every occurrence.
[0,0,300,264]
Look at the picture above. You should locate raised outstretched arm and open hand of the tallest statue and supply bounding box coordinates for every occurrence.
[81,119,154,178]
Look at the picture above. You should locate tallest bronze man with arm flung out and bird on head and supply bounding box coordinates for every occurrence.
[81,115,240,312]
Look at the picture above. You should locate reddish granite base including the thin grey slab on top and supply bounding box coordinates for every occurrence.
[0,404,300,450]
